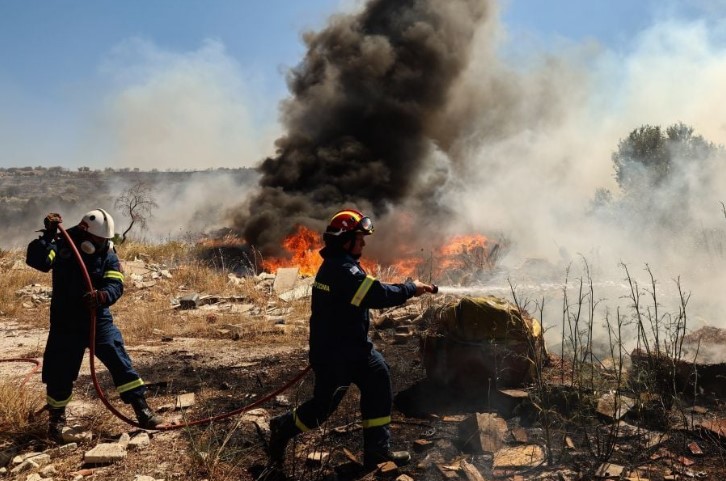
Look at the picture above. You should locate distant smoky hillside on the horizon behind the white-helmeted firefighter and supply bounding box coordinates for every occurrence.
[0,167,257,249]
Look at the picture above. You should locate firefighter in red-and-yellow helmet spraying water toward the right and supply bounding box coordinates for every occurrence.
[268,209,432,471]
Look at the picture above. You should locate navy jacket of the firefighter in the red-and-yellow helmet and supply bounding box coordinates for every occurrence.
[309,247,416,363]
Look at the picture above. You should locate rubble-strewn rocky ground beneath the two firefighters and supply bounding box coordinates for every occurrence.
[0,262,726,481]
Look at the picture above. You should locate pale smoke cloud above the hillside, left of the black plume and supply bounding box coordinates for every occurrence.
[82,38,278,170]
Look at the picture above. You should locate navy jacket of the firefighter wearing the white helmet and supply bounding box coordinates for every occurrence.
[25,227,124,328]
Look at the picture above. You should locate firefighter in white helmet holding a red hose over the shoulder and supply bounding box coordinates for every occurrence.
[26,209,162,442]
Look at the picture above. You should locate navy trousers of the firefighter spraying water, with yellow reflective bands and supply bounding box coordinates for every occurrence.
[293,349,393,451]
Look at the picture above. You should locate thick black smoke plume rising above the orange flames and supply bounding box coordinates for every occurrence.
[234,0,487,255]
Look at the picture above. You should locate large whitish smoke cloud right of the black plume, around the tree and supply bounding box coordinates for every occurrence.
[426,8,726,338]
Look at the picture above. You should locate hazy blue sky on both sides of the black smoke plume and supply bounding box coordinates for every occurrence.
[0,0,726,169]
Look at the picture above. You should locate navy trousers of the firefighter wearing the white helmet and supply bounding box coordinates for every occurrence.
[42,320,146,407]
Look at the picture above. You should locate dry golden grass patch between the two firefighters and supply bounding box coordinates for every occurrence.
[113,242,309,344]
